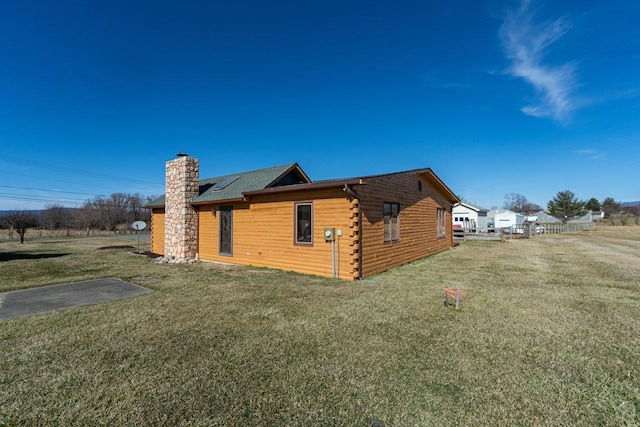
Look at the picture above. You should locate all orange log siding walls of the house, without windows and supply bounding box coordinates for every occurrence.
[151,168,453,280]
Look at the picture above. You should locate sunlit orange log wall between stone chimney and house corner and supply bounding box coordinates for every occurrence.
[198,189,359,279]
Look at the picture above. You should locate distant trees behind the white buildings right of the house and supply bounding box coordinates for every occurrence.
[503,190,640,225]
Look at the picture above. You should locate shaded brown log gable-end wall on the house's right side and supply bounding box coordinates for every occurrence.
[354,172,453,277]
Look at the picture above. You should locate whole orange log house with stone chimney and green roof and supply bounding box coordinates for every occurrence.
[147,155,459,280]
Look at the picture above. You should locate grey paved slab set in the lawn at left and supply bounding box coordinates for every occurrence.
[0,278,152,321]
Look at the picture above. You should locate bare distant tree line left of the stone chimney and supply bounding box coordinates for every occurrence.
[0,193,156,243]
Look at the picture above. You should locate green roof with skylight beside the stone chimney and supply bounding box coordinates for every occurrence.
[148,163,310,207]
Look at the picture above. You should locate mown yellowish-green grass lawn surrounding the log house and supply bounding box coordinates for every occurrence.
[0,226,640,426]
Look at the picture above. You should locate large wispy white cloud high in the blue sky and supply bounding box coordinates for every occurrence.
[500,0,578,122]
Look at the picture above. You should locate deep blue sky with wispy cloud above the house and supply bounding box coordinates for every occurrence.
[0,0,640,210]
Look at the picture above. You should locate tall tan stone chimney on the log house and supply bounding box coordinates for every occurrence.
[164,154,199,261]
